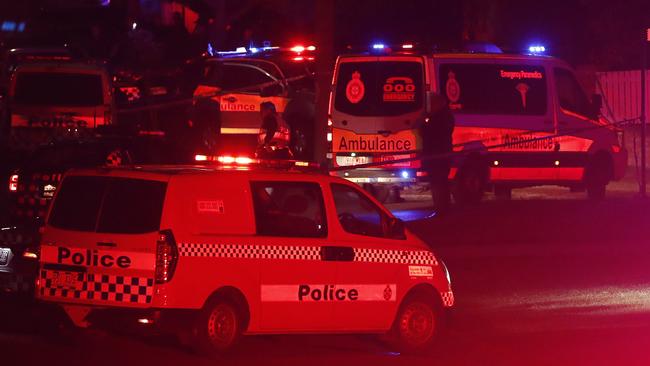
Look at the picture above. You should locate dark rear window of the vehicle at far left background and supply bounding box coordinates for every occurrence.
[14,72,104,107]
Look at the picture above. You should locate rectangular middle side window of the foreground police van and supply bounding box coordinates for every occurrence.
[251,182,327,238]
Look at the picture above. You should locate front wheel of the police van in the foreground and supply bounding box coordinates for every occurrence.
[391,295,442,353]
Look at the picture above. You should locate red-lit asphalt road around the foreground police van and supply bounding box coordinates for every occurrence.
[0,186,650,366]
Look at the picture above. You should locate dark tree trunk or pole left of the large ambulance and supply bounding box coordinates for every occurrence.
[312,0,336,163]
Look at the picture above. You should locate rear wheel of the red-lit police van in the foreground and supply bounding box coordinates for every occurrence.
[193,298,243,355]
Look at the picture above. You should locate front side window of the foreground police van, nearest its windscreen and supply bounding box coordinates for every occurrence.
[332,184,388,237]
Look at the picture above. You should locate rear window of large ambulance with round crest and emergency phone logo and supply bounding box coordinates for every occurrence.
[334,61,424,116]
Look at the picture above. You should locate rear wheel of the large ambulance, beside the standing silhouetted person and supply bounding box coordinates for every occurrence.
[453,159,489,205]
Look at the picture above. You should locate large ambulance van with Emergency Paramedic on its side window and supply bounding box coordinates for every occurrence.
[328,44,627,202]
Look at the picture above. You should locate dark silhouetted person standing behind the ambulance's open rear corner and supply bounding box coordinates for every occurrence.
[420,94,455,214]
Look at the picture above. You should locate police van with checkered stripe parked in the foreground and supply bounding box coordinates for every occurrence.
[37,157,454,352]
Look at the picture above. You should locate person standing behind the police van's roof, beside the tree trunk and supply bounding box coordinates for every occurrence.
[257,102,292,159]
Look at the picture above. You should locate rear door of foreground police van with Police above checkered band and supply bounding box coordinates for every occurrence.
[38,175,167,307]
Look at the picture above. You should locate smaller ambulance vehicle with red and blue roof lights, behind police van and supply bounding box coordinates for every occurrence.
[191,46,315,158]
